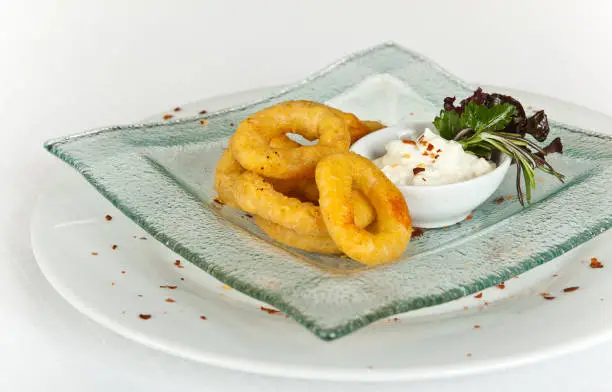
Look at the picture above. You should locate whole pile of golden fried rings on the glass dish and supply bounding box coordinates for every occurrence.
[215,101,411,264]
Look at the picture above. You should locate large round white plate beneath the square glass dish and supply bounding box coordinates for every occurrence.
[31,88,612,381]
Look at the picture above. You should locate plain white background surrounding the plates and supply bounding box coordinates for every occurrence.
[0,0,612,392]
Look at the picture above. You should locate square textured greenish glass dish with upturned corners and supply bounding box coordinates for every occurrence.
[46,44,612,340]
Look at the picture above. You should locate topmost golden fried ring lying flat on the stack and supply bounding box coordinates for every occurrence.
[230,101,351,179]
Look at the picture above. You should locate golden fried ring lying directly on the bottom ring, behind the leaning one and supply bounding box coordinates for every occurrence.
[233,172,375,236]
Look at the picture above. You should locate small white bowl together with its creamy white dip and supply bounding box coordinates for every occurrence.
[351,123,511,228]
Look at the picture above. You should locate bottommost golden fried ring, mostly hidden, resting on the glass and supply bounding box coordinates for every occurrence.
[255,215,342,254]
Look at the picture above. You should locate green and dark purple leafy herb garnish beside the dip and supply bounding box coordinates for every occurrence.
[433,88,564,205]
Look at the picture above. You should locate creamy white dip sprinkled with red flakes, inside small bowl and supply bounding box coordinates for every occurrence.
[374,129,496,185]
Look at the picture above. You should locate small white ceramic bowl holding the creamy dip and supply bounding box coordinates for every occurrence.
[351,122,511,228]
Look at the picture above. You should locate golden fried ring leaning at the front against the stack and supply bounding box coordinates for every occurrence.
[315,152,412,265]
